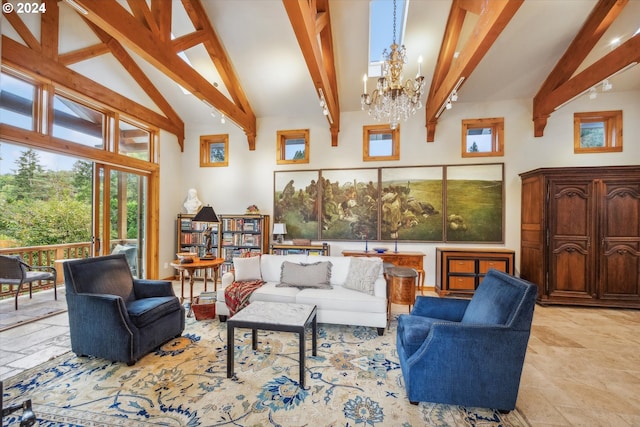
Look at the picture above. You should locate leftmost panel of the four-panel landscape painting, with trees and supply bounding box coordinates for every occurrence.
[273,170,320,240]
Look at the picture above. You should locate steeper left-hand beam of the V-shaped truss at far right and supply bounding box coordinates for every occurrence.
[533,0,629,137]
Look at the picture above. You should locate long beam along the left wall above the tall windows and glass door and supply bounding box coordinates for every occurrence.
[2,35,184,139]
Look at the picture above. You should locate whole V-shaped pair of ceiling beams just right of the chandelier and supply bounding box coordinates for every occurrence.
[425,0,524,142]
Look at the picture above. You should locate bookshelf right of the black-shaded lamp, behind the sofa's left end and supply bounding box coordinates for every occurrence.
[218,215,271,275]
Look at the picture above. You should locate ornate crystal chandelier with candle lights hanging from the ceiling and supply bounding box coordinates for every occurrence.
[360,0,424,129]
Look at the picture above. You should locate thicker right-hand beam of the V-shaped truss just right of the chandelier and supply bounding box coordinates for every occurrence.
[426,0,524,142]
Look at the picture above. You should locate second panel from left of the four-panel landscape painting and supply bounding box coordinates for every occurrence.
[320,169,379,240]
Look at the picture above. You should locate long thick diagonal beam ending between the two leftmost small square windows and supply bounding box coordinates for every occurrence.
[65,0,256,147]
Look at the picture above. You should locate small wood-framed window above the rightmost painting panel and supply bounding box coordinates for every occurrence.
[462,117,504,157]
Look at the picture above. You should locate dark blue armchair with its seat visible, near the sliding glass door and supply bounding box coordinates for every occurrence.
[64,254,185,365]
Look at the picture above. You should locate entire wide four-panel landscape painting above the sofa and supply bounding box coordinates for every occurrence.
[274,163,504,243]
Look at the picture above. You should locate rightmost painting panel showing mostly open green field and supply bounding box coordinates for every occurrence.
[445,163,504,243]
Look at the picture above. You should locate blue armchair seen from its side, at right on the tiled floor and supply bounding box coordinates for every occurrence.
[397,269,537,411]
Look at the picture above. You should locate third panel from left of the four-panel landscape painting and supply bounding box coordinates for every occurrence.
[380,166,444,241]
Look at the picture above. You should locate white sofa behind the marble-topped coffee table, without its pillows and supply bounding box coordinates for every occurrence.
[216,255,387,335]
